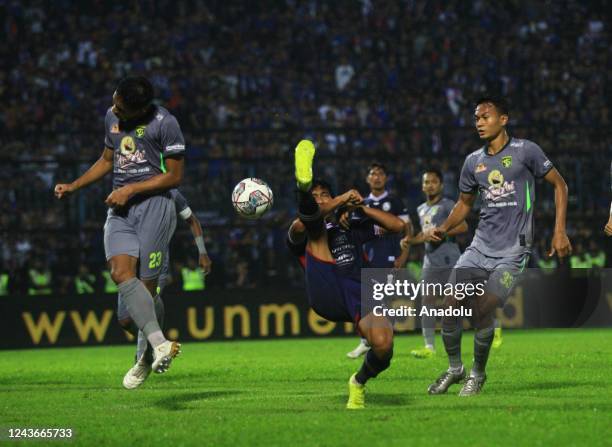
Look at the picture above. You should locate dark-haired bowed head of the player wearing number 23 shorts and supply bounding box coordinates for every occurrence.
[112,76,155,121]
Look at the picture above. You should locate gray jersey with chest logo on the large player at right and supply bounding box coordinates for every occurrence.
[459,138,553,257]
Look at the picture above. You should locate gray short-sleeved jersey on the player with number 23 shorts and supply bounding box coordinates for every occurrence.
[104,106,185,188]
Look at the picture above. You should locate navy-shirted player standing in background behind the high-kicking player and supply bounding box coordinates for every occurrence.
[346,162,412,359]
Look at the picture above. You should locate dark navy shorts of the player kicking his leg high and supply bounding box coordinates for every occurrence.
[306,251,361,324]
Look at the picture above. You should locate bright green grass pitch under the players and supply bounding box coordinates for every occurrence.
[0,330,612,447]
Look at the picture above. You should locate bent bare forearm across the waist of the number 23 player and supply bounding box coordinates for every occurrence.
[106,156,184,207]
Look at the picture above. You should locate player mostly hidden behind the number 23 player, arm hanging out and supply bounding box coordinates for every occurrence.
[122,189,212,390]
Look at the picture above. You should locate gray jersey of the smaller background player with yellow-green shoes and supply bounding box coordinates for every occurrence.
[417,197,461,267]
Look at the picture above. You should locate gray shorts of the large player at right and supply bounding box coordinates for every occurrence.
[449,247,529,304]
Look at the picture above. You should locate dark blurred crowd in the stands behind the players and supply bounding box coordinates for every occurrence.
[0,0,612,294]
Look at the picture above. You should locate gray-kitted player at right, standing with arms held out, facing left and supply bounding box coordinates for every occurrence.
[428,97,572,396]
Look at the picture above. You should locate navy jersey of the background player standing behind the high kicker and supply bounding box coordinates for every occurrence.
[364,191,410,268]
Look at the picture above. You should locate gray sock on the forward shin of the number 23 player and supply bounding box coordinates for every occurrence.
[117,278,166,347]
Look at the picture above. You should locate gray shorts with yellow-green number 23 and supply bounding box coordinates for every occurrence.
[104,195,176,279]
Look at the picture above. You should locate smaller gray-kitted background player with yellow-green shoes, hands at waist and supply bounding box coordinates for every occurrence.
[401,168,468,359]
